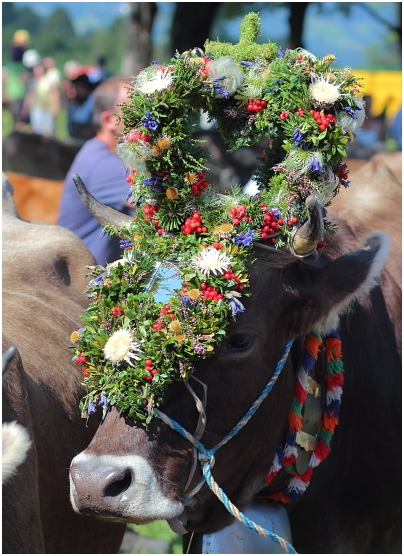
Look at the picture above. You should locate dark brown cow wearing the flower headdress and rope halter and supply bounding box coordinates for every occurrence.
[70,154,402,554]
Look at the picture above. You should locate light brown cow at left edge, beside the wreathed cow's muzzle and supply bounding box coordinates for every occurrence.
[2,175,125,554]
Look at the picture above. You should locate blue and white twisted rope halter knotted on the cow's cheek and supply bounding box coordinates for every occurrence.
[154,340,297,554]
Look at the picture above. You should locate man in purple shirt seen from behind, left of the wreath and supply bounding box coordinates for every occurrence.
[57,77,134,266]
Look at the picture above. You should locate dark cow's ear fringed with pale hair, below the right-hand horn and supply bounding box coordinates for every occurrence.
[300,233,390,333]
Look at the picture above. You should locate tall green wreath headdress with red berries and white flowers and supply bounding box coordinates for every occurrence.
[71,13,364,422]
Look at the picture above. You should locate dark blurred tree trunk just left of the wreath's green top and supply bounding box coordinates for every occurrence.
[171,2,222,55]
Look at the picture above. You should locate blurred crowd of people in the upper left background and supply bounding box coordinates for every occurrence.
[2,29,111,141]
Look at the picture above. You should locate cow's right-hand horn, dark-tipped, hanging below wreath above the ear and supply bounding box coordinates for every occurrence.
[291,196,324,257]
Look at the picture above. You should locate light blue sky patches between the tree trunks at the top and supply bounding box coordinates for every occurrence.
[8,1,396,69]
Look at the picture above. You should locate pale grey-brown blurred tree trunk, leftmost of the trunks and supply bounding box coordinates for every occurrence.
[121,2,157,77]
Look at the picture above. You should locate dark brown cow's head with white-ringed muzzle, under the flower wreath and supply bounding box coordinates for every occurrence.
[70,199,388,532]
